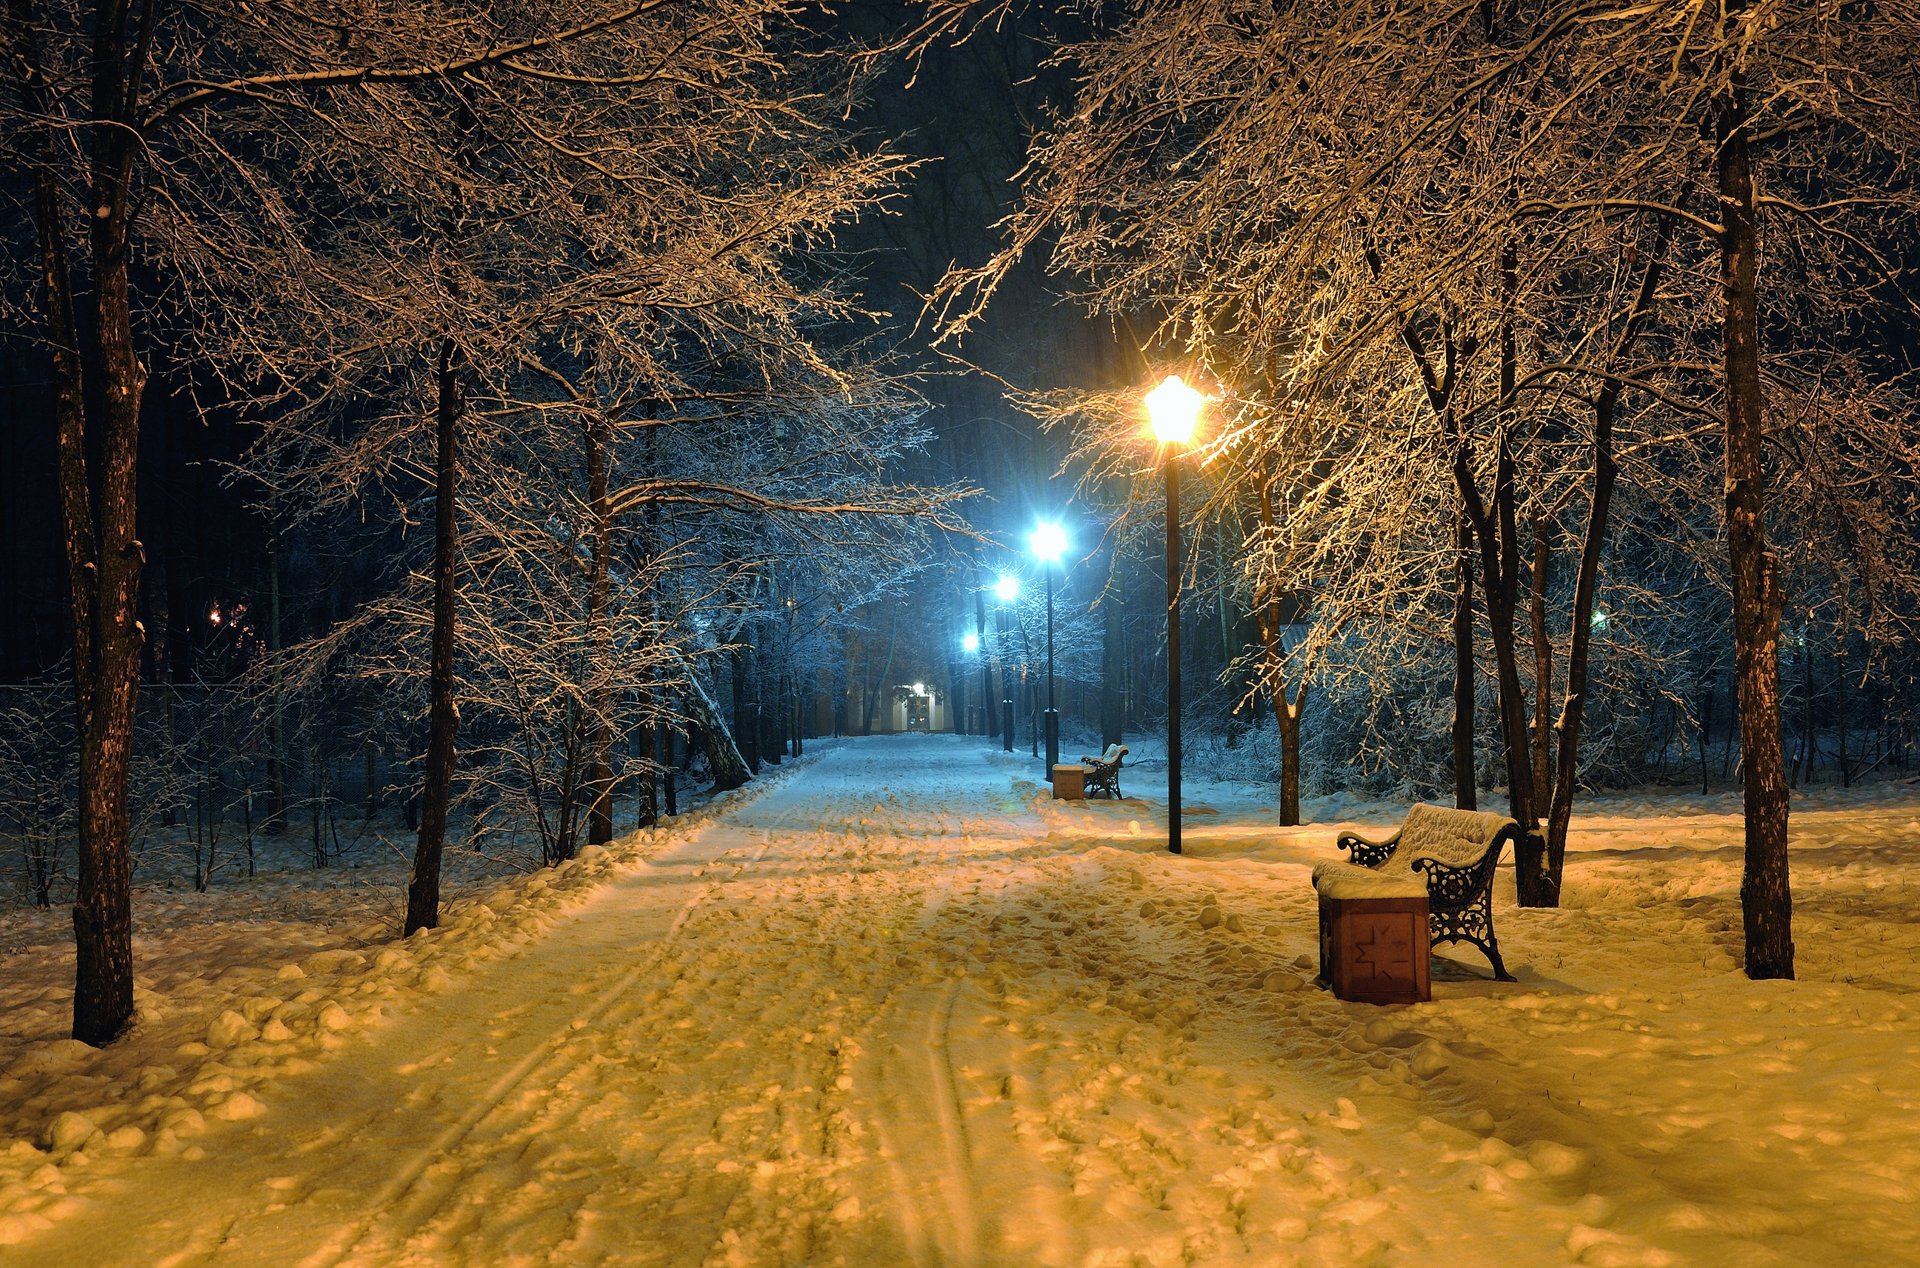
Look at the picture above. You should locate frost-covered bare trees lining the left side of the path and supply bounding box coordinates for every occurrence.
[0,0,962,1043]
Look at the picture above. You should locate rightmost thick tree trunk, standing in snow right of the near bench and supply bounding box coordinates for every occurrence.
[1715,66,1793,978]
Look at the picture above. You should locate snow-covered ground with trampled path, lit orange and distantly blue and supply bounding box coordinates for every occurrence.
[0,736,1920,1266]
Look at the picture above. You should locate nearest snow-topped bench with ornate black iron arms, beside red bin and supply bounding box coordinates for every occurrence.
[1313,803,1521,982]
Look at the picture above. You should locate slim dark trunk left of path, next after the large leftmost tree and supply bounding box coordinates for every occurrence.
[403,338,463,934]
